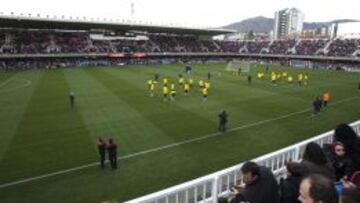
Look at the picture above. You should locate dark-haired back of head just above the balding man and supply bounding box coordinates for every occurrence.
[303,142,327,165]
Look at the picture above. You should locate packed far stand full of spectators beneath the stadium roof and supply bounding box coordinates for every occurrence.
[0,30,360,57]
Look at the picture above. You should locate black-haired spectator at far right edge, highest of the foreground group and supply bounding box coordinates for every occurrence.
[335,123,360,172]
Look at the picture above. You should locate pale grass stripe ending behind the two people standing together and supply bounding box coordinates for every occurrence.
[66,69,175,154]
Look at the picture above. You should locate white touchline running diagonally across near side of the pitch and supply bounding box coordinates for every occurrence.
[0,96,358,188]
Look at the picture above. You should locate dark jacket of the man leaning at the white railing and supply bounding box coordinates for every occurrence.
[231,166,280,203]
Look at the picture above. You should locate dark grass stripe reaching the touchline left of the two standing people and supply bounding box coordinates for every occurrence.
[0,70,96,182]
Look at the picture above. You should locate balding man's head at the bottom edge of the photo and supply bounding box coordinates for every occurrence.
[298,174,338,203]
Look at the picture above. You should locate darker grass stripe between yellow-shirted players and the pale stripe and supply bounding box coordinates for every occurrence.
[93,70,214,141]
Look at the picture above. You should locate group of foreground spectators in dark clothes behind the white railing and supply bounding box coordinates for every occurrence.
[219,124,360,203]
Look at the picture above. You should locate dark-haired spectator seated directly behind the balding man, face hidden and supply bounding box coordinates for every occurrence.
[301,142,336,181]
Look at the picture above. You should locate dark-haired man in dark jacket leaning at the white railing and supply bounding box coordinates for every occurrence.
[230,161,280,203]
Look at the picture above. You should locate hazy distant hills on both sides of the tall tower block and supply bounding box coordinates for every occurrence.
[222,16,359,33]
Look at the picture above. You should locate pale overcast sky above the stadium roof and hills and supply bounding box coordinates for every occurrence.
[0,0,360,27]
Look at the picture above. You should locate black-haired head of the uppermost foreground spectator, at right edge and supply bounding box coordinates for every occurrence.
[335,123,358,147]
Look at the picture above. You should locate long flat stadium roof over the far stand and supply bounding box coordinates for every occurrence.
[0,15,236,36]
